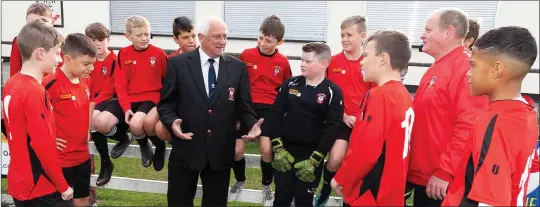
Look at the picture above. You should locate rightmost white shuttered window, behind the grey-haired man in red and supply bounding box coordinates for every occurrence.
[366,1,498,45]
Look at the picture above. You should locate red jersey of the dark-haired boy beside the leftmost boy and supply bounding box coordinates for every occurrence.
[43,69,93,167]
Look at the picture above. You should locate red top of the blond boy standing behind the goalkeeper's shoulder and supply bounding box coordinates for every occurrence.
[326,52,376,116]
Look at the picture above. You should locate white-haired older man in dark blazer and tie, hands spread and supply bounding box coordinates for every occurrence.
[157,17,263,206]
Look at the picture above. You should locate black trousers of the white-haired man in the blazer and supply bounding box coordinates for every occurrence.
[167,160,231,206]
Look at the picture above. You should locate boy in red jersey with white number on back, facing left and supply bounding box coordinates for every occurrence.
[331,30,414,206]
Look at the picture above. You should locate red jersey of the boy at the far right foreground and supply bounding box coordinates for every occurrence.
[443,99,538,206]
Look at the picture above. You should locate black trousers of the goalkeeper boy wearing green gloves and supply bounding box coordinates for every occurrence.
[274,150,324,207]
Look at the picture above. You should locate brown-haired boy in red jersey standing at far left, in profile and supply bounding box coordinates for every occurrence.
[2,20,73,206]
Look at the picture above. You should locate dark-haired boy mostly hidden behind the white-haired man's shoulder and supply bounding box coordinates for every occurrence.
[155,16,197,142]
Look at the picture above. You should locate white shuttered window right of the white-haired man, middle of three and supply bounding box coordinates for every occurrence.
[224,1,328,41]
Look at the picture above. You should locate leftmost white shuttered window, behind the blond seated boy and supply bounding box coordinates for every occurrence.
[110,1,195,36]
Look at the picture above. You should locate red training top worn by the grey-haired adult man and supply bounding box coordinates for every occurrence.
[407,46,488,186]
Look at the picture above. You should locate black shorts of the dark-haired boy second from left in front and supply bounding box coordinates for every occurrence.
[62,159,92,198]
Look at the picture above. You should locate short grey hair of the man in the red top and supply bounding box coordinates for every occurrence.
[433,8,469,39]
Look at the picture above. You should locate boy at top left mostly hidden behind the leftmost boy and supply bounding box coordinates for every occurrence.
[9,2,54,77]
